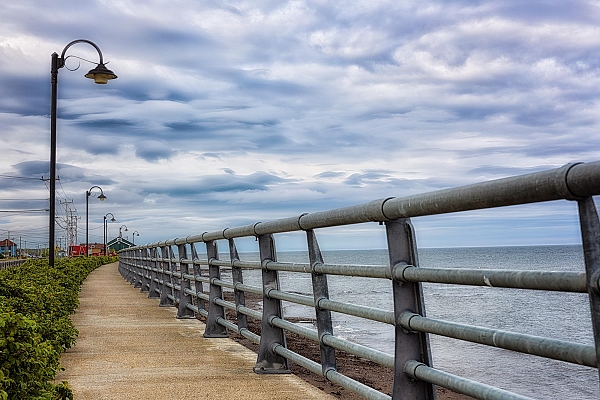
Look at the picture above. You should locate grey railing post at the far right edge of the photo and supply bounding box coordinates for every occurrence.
[578,197,600,382]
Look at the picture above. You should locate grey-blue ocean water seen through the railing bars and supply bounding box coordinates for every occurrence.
[218,246,600,400]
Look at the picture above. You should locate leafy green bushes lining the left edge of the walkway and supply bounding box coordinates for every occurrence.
[0,257,117,400]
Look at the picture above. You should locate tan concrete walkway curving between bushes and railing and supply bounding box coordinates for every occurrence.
[56,263,333,400]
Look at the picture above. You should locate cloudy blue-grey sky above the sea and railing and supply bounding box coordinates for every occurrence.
[0,0,600,253]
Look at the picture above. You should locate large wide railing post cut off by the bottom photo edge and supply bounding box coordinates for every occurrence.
[386,218,436,400]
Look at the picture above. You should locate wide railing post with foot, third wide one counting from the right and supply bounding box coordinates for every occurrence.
[203,240,229,338]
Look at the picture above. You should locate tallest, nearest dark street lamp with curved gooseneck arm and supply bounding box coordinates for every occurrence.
[48,39,117,267]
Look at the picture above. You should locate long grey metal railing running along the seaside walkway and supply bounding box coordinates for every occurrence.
[119,162,600,399]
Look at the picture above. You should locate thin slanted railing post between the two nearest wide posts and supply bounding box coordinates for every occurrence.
[306,229,337,377]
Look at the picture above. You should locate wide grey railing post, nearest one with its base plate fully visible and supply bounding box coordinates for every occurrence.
[253,234,290,374]
